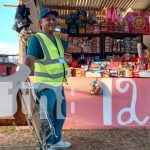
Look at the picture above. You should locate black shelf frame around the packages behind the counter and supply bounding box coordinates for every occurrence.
[69,32,143,59]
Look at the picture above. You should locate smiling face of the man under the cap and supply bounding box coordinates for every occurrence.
[40,14,57,33]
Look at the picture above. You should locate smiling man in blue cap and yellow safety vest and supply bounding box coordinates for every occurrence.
[25,8,81,148]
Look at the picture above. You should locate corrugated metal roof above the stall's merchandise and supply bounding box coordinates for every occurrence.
[35,0,150,16]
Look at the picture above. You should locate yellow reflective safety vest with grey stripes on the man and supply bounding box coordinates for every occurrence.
[33,32,68,87]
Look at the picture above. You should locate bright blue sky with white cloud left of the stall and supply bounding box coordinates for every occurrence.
[0,0,19,54]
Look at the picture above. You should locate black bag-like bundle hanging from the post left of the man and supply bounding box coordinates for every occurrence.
[13,5,32,33]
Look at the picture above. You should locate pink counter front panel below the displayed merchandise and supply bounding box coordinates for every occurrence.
[64,77,150,129]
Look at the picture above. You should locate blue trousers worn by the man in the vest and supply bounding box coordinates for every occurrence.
[34,87,66,144]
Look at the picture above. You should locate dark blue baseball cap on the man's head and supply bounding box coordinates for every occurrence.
[39,8,58,20]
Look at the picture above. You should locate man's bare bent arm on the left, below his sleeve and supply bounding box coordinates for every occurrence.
[25,55,35,76]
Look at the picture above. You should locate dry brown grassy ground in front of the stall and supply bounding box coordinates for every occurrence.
[0,127,150,150]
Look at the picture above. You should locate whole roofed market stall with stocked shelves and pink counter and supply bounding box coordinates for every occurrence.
[1,0,150,129]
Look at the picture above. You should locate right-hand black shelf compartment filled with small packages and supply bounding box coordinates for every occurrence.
[100,32,143,58]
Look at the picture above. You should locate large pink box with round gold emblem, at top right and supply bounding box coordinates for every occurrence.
[126,12,150,34]
